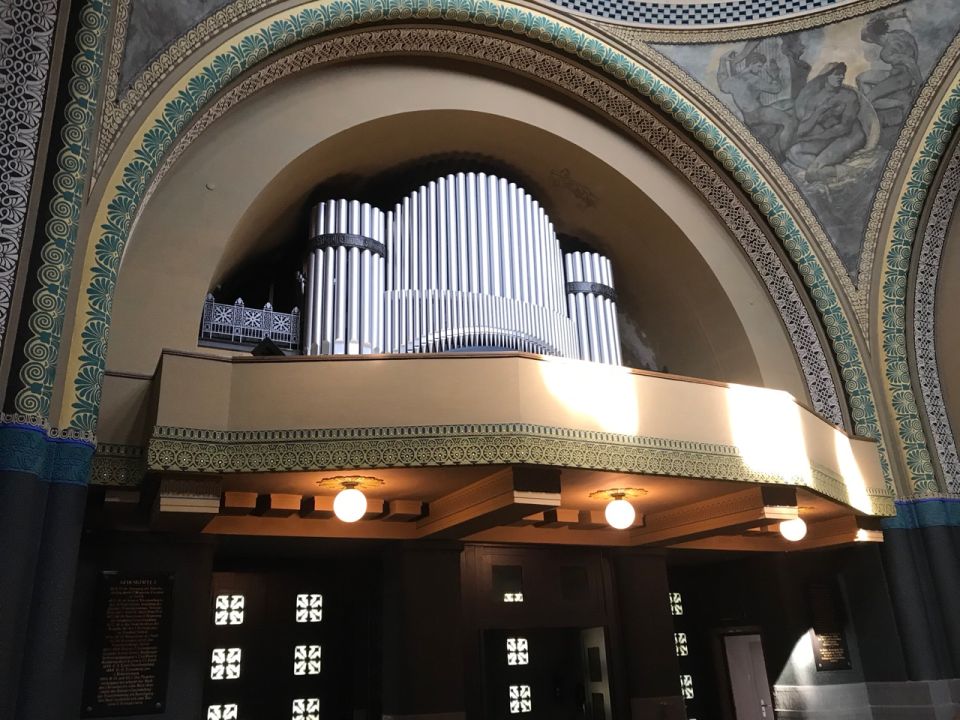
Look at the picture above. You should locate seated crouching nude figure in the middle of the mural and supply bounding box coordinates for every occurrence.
[787,63,867,182]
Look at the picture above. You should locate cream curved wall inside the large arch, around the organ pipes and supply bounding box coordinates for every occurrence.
[105,63,804,397]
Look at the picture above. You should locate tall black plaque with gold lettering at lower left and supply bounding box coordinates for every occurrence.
[83,572,173,717]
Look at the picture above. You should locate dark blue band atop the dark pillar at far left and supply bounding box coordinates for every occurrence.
[0,423,94,485]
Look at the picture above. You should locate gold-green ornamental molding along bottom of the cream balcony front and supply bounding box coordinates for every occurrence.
[139,423,896,515]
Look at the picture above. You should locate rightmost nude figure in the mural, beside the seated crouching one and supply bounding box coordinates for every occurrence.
[857,15,923,125]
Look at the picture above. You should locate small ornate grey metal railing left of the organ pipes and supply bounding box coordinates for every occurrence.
[200,295,300,352]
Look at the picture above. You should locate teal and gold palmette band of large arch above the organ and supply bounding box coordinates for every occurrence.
[18,0,889,475]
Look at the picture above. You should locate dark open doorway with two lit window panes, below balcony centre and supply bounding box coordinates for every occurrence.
[483,628,610,720]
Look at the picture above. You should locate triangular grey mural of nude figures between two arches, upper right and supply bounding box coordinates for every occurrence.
[653,0,960,282]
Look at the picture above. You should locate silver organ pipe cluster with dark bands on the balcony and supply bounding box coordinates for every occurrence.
[303,173,621,364]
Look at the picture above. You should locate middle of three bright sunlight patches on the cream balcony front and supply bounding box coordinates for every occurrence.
[727,385,813,484]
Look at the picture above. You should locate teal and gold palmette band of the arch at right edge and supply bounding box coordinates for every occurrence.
[876,77,960,495]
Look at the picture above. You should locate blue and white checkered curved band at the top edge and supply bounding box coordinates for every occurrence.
[551,0,840,26]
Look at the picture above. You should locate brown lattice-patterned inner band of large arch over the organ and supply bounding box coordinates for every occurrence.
[137,35,844,425]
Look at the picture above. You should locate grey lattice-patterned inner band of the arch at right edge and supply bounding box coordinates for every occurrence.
[913,135,960,493]
